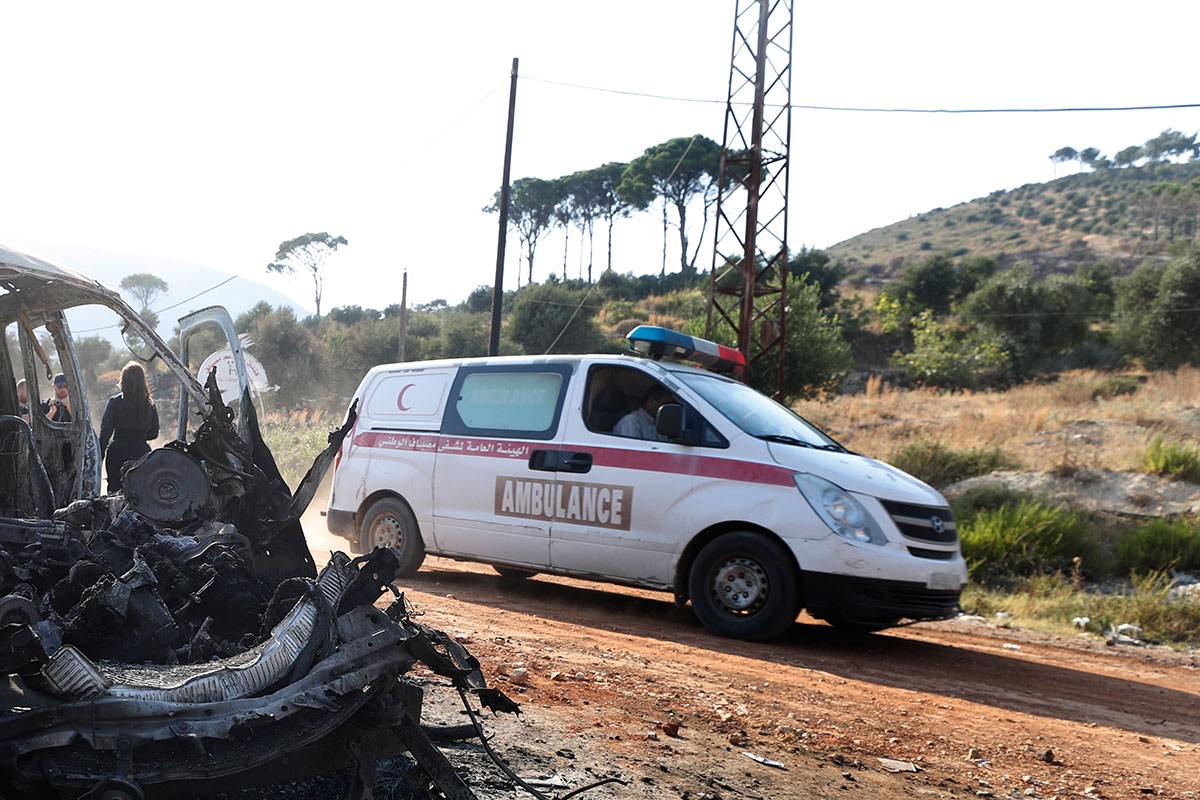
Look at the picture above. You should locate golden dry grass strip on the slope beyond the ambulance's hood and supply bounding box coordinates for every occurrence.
[793,368,1200,471]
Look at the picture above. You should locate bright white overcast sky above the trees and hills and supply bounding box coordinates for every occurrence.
[0,0,1200,309]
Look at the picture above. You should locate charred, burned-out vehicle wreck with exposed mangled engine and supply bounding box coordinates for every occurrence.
[0,247,528,800]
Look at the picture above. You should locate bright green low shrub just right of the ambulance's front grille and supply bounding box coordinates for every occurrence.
[959,500,1092,585]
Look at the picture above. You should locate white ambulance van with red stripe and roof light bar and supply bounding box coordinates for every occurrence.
[328,325,967,640]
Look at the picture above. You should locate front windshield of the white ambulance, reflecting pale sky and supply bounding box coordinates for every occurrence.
[676,372,842,450]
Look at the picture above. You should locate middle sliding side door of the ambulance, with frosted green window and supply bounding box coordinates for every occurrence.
[433,362,572,569]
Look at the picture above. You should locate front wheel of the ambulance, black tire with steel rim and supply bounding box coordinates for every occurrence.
[688,531,802,642]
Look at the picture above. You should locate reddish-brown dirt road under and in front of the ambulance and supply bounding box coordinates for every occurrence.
[297,525,1200,800]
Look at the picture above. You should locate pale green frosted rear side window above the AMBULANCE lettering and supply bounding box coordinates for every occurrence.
[442,365,571,439]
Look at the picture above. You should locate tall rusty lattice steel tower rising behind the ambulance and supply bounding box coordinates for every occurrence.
[707,0,792,395]
